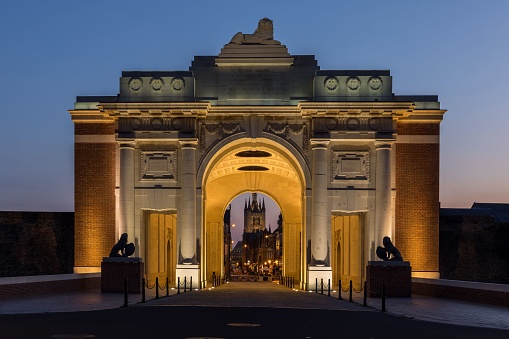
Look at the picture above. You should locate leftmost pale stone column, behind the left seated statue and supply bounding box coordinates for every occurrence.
[115,141,136,242]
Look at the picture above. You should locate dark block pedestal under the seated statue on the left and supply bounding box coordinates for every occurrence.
[101,257,145,294]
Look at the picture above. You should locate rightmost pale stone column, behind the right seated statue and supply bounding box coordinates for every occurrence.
[371,141,394,260]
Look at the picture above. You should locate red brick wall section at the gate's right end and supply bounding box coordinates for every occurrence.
[395,122,440,272]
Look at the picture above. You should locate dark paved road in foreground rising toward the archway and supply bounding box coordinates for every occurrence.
[0,283,509,339]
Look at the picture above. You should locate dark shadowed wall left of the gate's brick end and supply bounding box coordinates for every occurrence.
[0,212,74,277]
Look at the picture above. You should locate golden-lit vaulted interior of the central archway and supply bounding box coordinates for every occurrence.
[202,140,305,280]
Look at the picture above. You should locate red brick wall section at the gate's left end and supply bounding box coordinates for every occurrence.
[74,123,116,267]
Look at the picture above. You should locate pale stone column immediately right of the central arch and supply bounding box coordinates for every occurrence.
[311,139,330,266]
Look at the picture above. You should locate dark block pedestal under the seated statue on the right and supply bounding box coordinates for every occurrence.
[366,261,412,298]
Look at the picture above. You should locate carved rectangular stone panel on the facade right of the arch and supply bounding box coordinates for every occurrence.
[332,151,369,181]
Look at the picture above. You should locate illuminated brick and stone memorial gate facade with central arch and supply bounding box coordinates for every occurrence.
[69,19,445,288]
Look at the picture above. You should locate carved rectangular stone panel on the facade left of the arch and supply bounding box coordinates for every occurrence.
[140,151,177,180]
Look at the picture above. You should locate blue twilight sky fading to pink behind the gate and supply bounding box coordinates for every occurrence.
[0,0,509,242]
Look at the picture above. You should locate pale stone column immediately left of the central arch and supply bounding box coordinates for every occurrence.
[179,139,198,265]
